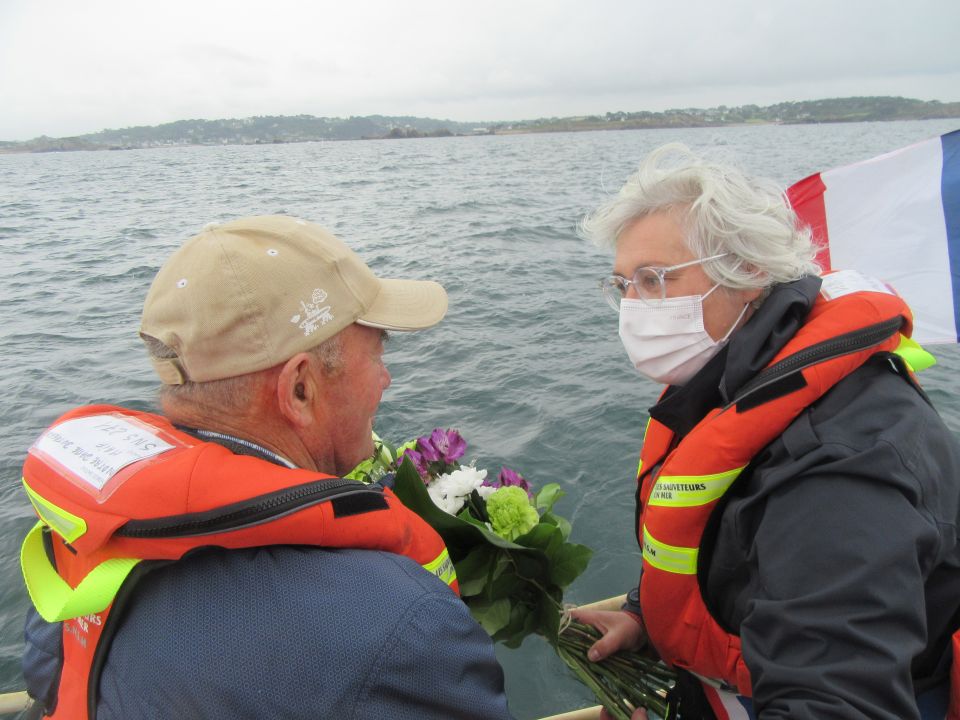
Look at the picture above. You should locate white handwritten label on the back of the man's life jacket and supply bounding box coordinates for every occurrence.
[34,415,174,490]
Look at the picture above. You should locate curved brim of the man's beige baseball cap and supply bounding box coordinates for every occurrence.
[357,278,447,331]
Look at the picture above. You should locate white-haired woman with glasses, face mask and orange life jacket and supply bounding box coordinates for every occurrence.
[577,145,960,720]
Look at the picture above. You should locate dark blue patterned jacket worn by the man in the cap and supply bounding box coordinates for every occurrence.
[24,546,510,720]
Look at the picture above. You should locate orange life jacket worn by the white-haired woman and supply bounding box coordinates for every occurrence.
[637,284,912,696]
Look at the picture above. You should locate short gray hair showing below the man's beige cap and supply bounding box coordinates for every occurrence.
[140,333,343,413]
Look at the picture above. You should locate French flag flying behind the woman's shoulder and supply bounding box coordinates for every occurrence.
[787,130,960,343]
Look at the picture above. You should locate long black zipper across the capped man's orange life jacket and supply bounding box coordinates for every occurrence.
[115,478,382,539]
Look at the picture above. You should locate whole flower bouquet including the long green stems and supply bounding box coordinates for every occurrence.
[348,428,673,720]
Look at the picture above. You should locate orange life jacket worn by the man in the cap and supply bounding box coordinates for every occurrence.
[21,406,458,720]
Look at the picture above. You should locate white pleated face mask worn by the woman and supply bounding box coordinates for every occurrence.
[620,285,749,385]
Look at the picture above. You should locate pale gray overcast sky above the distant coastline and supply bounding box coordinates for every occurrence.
[0,0,960,140]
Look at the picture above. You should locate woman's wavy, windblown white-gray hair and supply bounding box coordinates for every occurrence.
[580,143,820,289]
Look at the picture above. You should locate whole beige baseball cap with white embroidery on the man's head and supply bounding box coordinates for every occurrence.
[140,215,447,385]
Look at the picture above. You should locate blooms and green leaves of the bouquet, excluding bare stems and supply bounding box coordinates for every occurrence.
[348,428,592,647]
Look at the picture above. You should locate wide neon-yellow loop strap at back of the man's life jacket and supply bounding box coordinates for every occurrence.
[20,522,140,622]
